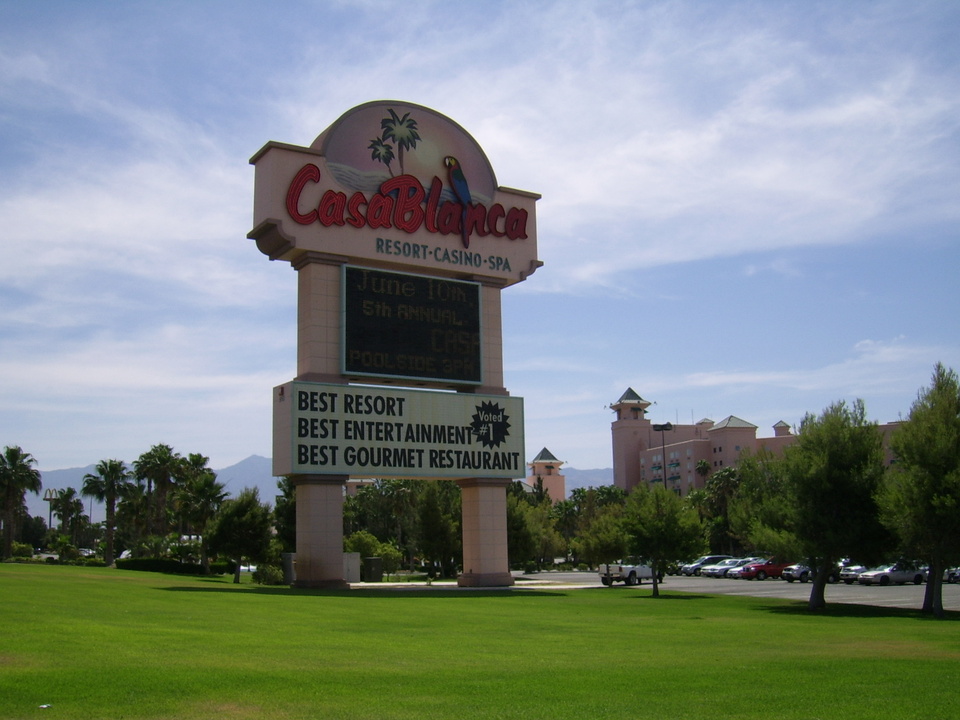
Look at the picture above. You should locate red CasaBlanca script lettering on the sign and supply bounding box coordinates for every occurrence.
[286,163,527,247]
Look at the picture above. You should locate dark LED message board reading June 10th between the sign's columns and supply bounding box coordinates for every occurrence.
[341,265,482,385]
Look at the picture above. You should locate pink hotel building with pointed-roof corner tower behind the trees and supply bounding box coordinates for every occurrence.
[610,388,898,495]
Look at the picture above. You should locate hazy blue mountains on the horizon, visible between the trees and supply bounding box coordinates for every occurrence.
[27,455,613,523]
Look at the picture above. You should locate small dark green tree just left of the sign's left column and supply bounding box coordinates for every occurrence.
[210,488,271,583]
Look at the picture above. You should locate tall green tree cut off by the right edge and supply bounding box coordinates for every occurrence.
[879,363,960,618]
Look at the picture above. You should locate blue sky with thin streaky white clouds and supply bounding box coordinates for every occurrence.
[0,0,960,478]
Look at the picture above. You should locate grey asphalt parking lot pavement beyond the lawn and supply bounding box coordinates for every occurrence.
[516,572,960,611]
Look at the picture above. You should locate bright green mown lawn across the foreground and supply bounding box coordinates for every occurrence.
[0,564,960,720]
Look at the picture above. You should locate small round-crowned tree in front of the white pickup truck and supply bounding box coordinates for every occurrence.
[625,485,703,597]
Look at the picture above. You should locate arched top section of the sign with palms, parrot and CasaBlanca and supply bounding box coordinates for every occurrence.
[248,101,541,287]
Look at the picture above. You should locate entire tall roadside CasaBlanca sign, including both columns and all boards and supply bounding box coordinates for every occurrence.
[248,101,541,587]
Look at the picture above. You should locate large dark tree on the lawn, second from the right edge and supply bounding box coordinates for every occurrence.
[783,400,889,610]
